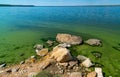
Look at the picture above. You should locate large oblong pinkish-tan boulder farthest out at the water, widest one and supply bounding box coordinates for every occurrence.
[56,33,82,45]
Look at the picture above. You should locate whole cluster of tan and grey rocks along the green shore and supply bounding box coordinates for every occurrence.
[1,34,103,77]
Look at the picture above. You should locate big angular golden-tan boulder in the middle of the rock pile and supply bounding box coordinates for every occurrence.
[51,46,72,63]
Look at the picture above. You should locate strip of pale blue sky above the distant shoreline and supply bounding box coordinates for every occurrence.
[0,0,120,6]
